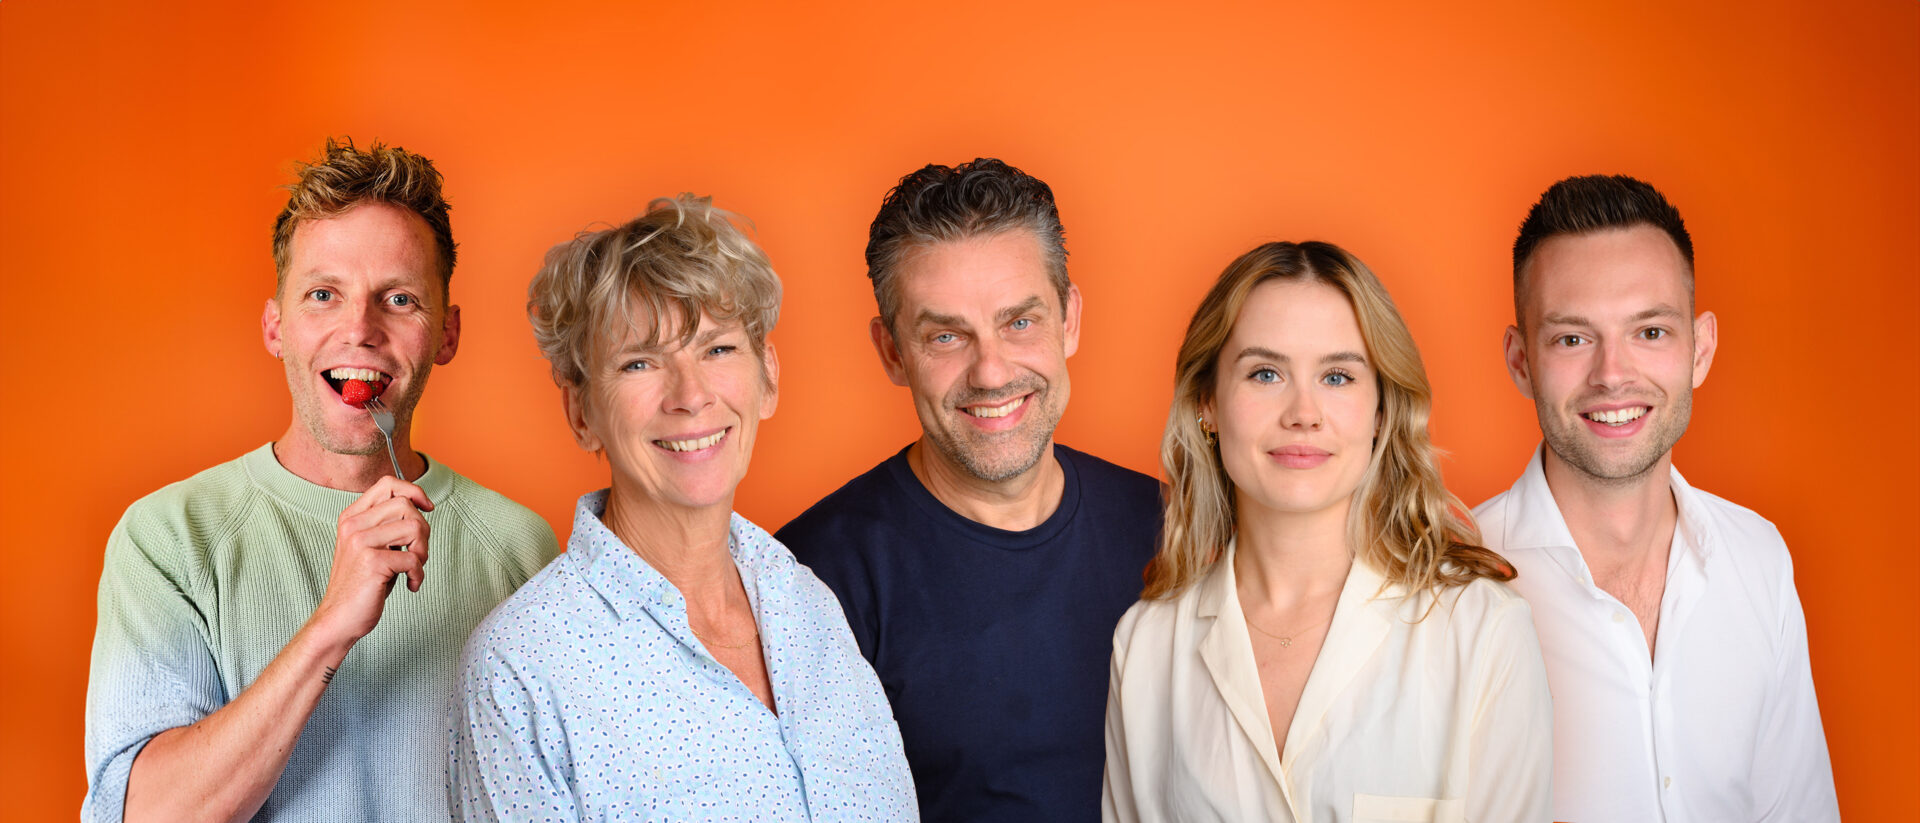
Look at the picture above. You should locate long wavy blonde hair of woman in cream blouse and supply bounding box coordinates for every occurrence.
[1140,242,1515,600]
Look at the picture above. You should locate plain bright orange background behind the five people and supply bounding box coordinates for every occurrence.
[0,0,1920,819]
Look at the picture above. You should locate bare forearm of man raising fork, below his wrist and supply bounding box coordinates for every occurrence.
[125,625,351,823]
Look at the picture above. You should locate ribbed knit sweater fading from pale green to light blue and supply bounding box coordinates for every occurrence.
[81,445,559,821]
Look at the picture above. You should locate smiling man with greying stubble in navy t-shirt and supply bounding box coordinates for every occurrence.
[776,159,1160,821]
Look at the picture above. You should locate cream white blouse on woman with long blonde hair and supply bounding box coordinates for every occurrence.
[1102,549,1553,823]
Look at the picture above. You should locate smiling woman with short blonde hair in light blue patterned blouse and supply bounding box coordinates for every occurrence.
[447,196,916,821]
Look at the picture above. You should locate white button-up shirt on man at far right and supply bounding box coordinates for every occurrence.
[1473,449,1839,823]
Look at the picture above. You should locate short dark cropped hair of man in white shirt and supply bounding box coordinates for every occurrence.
[1513,175,1693,324]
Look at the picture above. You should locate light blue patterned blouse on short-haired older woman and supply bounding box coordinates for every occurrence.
[447,491,920,821]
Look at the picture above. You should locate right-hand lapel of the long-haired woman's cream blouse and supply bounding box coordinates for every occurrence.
[1267,558,1400,773]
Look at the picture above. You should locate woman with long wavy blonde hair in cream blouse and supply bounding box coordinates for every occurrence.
[1104,242,1553,821]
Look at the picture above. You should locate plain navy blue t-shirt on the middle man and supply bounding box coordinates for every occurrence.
[774,445,1160,823]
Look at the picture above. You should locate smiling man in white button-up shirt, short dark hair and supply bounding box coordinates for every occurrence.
[1475,176,1839,823]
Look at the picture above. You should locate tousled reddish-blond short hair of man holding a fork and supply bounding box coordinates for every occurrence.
[273,138,455,294]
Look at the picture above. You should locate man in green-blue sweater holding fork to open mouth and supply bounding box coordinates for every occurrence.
[81,140,559,821]
